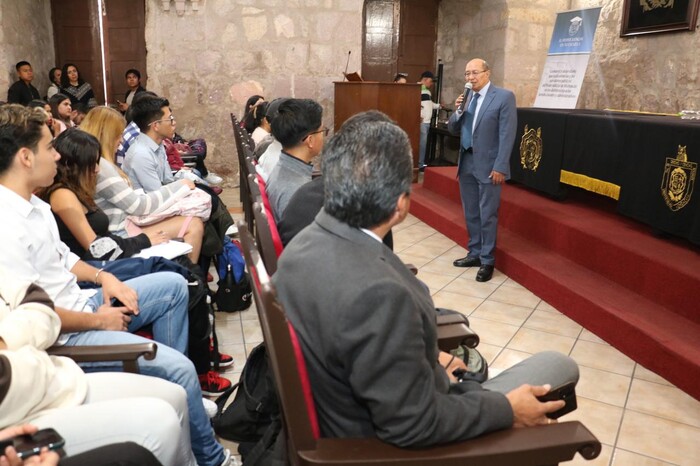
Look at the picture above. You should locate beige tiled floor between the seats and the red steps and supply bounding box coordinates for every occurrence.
[217,189,700,466]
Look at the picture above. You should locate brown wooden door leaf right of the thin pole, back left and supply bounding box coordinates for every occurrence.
[103,0,147,104]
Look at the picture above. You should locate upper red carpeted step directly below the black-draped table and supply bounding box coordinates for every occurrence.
[412,167,700,323]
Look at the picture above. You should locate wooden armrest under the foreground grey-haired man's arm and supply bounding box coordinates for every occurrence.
[298,421,601,466]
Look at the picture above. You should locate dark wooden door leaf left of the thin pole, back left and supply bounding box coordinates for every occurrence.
[51,0,104,102]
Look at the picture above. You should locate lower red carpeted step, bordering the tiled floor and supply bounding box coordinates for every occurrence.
[496,230,700,399]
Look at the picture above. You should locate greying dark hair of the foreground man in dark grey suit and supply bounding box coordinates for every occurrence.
[321,112,413,228]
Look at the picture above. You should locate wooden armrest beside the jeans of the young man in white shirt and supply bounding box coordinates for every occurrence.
[46,342,158,374]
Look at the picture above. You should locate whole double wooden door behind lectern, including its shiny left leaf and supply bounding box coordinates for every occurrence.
[362,0,439,82]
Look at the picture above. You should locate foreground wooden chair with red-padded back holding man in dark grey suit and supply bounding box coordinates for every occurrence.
[239,224,601,466]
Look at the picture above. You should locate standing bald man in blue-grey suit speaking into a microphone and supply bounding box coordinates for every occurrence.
[448,58,517,282]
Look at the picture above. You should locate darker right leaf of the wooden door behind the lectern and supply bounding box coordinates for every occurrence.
[397,0,438,82]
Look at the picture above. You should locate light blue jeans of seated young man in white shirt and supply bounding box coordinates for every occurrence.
[66,272,224,466]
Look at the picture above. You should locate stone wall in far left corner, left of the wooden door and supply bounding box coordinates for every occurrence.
[0,0,55,101]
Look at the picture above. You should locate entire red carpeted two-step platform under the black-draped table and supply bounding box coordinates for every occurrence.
[411,167,700,400]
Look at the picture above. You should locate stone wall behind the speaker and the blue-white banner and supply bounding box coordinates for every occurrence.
[437,0,700,113]
